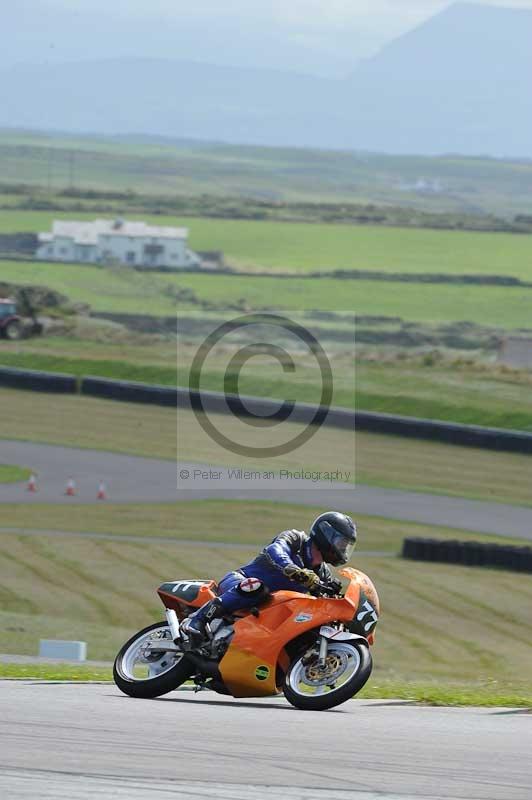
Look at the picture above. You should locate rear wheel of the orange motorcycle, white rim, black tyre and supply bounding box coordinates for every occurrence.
[113,622,194,698]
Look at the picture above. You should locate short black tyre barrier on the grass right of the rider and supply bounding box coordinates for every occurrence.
[401,538,532,572]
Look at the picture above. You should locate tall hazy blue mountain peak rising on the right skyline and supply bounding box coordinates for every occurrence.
[346,3,532,157]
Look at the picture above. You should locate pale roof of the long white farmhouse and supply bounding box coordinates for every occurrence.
[48,219,188,245]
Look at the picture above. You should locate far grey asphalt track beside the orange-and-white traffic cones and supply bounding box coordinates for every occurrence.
[0,440,532,539]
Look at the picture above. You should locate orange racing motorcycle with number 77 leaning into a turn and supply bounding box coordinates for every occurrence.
[113,567,379,711]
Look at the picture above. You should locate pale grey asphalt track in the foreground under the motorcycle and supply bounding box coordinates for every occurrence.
[0,681,532,800]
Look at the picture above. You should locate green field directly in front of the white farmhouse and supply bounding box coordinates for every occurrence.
[0,258,532,330]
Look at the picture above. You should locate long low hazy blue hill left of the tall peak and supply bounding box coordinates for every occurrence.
[0,59,337,144]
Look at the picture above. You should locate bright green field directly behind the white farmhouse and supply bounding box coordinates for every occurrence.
[0,209,532,280]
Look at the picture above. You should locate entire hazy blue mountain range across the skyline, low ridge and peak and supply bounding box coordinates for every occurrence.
[0,3,532,158]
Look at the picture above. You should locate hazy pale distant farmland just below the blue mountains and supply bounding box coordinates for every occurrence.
[0,131,532,215]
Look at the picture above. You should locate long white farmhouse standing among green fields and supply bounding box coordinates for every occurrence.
[35,219,201,269]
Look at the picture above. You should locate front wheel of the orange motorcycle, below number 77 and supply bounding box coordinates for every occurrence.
[283,641,373,711]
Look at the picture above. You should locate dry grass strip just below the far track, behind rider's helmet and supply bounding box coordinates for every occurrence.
[0,500,523,557]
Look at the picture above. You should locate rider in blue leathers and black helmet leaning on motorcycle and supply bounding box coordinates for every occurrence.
[181,511,357,646]
